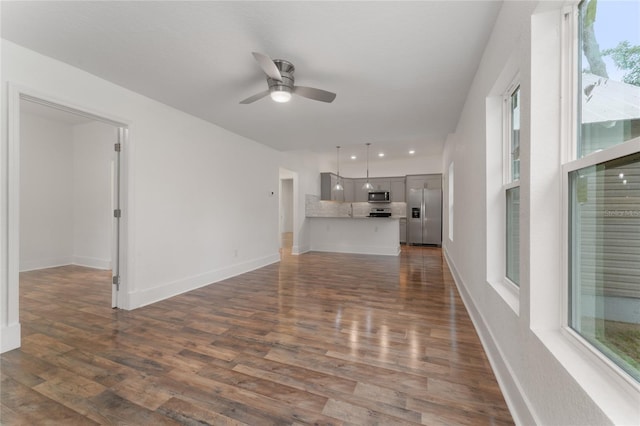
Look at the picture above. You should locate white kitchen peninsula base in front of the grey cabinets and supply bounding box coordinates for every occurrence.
[308,216,400,256]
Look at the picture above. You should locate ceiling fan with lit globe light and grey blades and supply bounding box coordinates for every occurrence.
[240,52,336,104]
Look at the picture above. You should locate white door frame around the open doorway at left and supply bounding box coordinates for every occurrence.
[0,83,130,352]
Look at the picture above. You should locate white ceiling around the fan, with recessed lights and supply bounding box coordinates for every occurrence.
[1,0,502,164]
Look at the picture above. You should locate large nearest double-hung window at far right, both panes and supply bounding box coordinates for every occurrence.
[565,0,640,381]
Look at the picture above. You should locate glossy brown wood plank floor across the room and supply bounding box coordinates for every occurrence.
[0,238,513,425]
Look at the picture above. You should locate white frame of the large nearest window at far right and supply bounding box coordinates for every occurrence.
[560,0,640,386]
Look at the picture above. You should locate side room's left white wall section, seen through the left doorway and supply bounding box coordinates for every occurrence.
[20,114,73,271]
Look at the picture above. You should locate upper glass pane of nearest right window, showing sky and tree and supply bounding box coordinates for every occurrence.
[577,0,640,157]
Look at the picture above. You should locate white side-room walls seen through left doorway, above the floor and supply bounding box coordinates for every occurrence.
[19,98,120,307]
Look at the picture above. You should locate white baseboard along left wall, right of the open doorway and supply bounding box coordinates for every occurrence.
[124,253,280,309]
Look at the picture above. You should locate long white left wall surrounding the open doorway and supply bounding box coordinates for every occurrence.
[0,40,282,350]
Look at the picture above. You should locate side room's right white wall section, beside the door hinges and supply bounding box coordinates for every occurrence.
[73,122,118,269]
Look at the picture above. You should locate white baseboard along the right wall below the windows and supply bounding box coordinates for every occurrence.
[443,248,540,425]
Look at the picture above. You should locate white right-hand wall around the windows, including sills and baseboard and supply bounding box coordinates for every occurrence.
[442,2,640,425]
